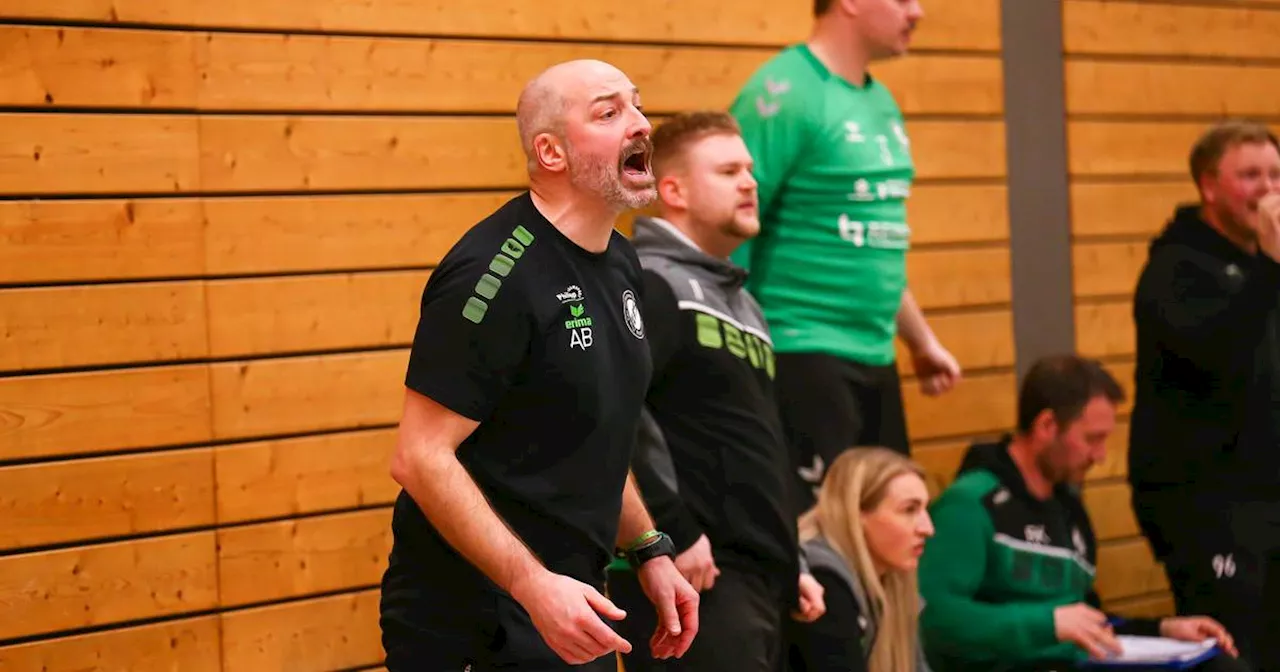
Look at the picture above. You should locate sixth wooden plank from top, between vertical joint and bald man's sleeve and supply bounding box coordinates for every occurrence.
[210,349,408,439]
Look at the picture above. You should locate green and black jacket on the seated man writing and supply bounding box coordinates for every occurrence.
[920,436,1158,672]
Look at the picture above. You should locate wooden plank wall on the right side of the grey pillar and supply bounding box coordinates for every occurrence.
[1064,0,1280,613]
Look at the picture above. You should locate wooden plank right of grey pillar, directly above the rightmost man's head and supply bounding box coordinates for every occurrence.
[1066,59,1280,116]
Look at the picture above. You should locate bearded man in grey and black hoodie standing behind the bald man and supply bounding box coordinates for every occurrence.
[609,111,822,672]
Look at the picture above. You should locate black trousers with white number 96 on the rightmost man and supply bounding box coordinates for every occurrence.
[1134,493,1280,672]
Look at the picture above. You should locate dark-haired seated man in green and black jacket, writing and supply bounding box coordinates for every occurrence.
[919,356,1240,672]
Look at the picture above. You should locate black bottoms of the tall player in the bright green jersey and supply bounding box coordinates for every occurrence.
[774,353,910,515]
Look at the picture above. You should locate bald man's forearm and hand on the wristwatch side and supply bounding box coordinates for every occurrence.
[617,474,698,659]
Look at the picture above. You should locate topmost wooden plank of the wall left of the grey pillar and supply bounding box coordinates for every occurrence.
[0,0,1000,50]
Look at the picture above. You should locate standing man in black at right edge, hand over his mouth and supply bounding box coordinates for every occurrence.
[1129,122,1280,669]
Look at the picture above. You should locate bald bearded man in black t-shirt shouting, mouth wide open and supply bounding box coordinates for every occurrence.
[381,60,698,672]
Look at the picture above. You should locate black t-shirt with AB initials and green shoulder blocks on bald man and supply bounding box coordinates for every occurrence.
[383,193,652,622]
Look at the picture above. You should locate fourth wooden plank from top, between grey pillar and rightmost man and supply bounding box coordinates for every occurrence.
[1071,180,1198,238]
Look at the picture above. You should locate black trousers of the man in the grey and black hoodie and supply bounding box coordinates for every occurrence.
[609,567,785,672]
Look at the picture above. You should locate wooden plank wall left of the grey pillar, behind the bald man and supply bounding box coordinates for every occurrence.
[0,0,1018,671]
